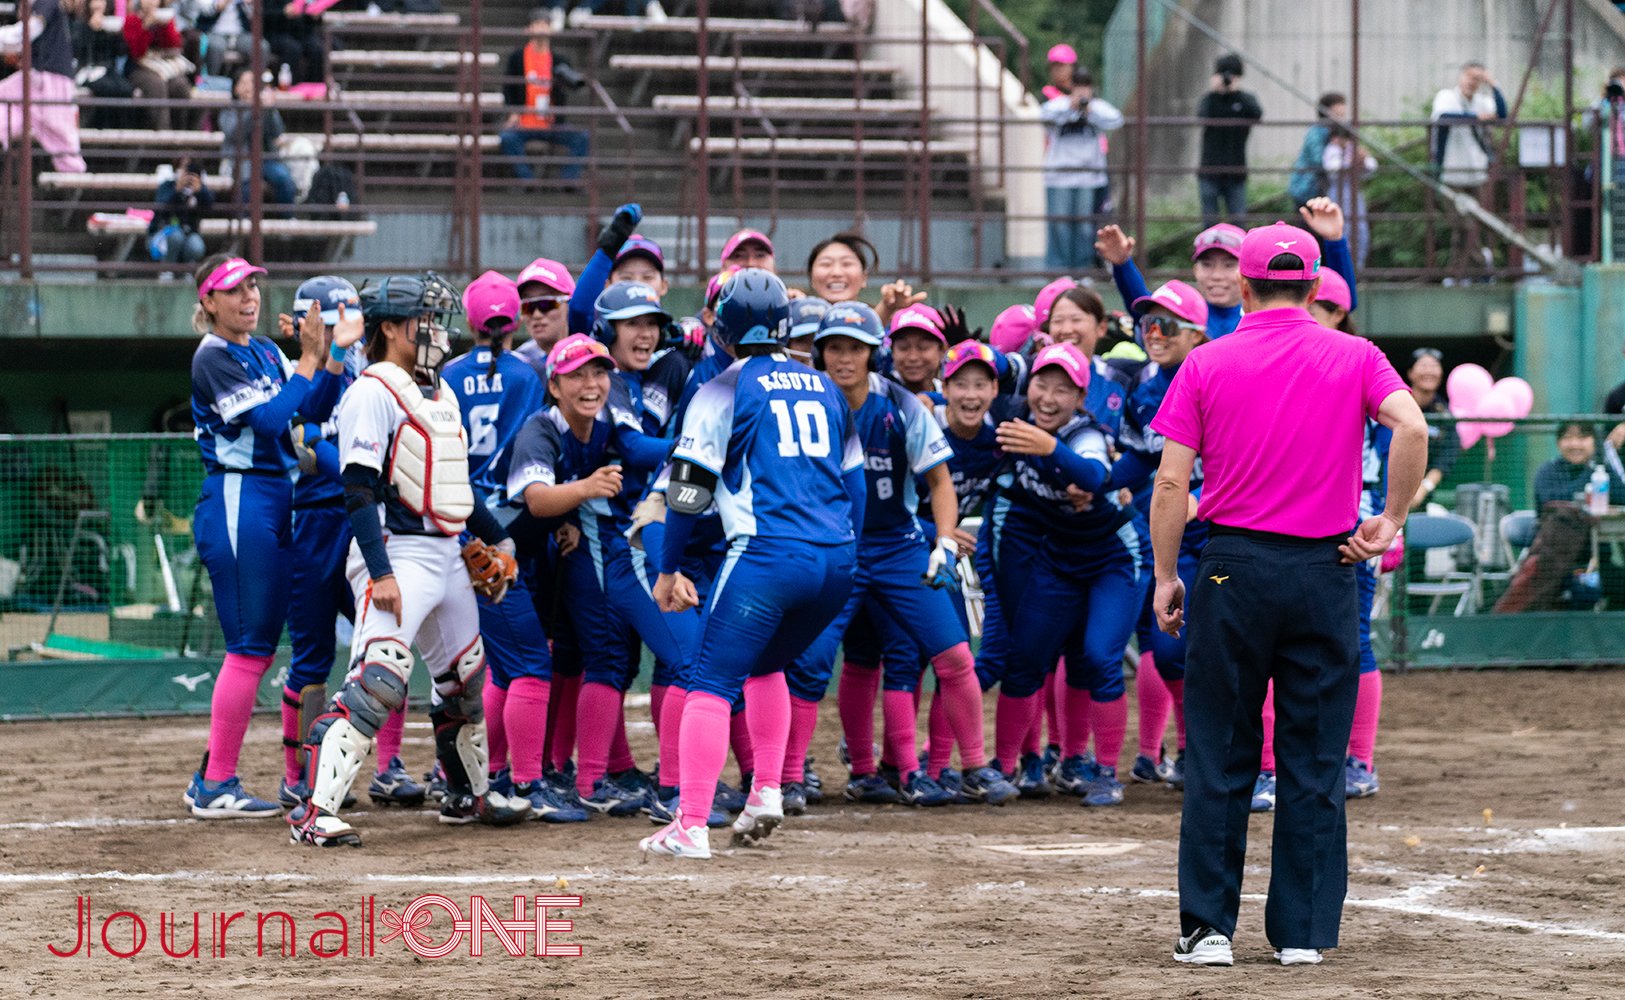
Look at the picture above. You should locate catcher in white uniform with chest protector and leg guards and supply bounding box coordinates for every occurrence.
[288,272,530,847]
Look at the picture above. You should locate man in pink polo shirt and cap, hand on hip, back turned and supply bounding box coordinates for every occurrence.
[1151,223,1427,966]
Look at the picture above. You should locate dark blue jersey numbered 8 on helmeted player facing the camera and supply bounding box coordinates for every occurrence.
[852,372,954,535]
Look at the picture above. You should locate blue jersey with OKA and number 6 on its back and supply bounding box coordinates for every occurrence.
[440,348,546,507]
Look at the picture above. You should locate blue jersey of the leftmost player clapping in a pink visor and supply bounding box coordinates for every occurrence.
[192,333,299,475]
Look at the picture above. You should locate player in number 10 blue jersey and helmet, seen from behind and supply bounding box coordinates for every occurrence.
[640,268,865,859]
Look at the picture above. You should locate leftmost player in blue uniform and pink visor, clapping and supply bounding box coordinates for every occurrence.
[182,254,343,820]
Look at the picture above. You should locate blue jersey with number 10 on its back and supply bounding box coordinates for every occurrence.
[673,354,863,545]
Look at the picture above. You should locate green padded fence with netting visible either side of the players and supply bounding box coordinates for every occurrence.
[0,415,1625,719]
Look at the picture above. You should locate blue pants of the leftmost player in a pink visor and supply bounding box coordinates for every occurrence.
[192,472,294,657]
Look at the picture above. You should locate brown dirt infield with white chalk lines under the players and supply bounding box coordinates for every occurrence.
[0,672,1625,1000]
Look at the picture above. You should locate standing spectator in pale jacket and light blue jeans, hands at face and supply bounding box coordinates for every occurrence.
[1038,65,1123,272]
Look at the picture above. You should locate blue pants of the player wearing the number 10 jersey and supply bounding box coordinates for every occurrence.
[689,537,856,702]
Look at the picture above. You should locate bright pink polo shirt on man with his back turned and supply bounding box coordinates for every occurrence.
[1151,309,1406,538]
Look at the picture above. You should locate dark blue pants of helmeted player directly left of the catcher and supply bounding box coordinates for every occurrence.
[288,499,356,691]
